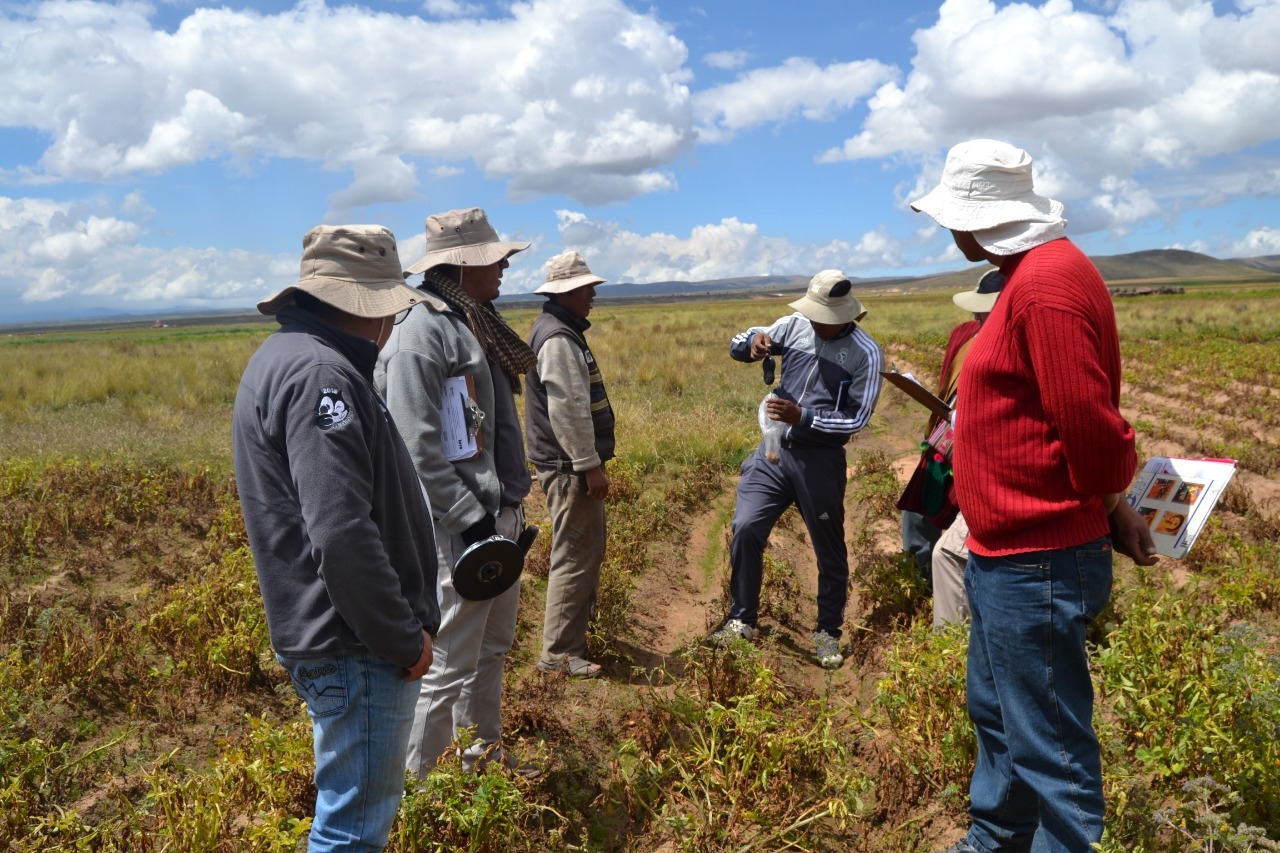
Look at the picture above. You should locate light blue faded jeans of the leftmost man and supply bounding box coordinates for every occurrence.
[276,654,419,853]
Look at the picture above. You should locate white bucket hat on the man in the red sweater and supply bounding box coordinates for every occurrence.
[911,140,1062,232]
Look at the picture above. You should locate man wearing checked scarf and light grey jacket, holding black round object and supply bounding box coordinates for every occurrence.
[375,207,536,775]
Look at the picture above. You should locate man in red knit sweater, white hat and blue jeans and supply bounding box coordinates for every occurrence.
[911,140,1156,853]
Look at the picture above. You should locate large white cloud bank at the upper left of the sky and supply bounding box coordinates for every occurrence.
[0,0,694,207]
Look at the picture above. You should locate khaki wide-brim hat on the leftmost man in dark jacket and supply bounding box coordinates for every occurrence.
[257,225,422,319]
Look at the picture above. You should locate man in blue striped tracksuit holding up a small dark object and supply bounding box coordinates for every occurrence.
[712,269,884,669]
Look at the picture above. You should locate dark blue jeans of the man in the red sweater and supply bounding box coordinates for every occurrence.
[965,538,1111,853]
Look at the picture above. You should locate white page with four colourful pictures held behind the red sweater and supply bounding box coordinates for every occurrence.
[1129,456,1235,558]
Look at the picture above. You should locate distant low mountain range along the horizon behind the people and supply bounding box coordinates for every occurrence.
[10,248,1280,332]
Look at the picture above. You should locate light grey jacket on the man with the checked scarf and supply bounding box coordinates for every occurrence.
[374,291,512,535]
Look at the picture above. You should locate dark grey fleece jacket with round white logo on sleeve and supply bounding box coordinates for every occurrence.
[232,306,440,667]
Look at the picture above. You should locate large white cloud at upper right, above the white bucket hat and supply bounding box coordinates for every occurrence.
[822,0,1280,239]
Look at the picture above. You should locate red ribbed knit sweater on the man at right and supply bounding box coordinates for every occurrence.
[954,238,1137,557]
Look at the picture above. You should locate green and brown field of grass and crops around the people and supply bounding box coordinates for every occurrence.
[0,283,1280,853]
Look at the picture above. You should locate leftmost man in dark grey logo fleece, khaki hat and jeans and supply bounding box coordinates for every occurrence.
[232,225,440,853]
